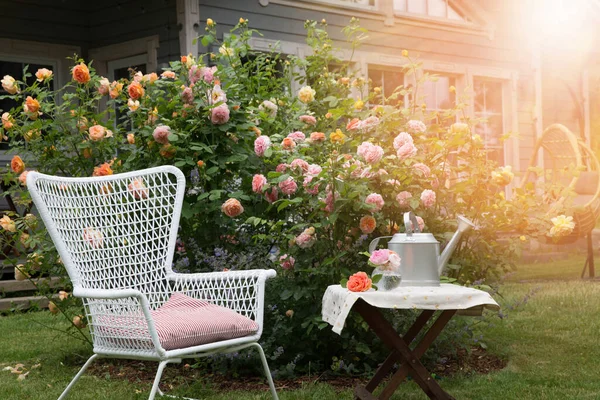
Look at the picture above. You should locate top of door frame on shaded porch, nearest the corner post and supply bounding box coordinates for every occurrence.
[89,35,159,76]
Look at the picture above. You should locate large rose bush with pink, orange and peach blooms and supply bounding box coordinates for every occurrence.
[0,19,570,373]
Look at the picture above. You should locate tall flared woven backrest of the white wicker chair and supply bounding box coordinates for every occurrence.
[27,166,185,308]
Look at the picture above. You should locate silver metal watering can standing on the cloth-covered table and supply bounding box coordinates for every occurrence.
[369,211,474,286]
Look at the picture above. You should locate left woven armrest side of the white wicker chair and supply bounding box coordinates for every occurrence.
[73,287,165,356]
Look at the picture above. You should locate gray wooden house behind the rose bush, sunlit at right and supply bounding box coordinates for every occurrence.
[0,0,600,176]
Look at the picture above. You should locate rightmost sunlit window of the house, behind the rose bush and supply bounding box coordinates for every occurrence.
[473,79,504,165]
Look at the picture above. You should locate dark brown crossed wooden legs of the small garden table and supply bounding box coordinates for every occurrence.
[354,300,457,400]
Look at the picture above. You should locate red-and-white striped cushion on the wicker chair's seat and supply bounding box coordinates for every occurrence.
[152,293,258,350]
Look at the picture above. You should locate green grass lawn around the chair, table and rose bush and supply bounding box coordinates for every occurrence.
[0,255,600,400]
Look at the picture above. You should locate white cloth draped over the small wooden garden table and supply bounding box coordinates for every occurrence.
[322,283,500,334]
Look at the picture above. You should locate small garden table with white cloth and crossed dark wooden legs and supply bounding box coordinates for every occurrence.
[322,284,499,400]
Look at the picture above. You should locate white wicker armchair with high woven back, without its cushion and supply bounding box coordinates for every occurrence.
[27,166,277,399]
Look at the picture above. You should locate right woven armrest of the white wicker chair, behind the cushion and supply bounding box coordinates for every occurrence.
[167,269,277,333]
